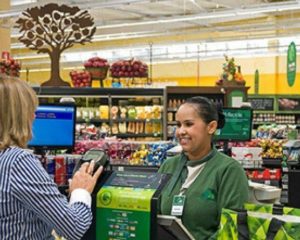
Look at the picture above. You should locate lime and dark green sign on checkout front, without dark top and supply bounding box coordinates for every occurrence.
[96,186,155,240]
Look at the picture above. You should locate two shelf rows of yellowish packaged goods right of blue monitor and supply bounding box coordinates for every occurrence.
[77,105,163,139]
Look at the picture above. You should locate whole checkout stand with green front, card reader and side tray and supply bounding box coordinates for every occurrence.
[73,148,193,240]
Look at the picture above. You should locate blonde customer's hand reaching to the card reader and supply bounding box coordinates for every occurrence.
[69,161,103,193]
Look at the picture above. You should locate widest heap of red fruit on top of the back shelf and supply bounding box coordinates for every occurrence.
[110,59,148,78]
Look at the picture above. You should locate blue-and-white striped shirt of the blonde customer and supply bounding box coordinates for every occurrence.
[0,147,92,240]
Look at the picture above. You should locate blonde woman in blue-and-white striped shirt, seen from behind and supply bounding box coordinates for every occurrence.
[0,75,102,240]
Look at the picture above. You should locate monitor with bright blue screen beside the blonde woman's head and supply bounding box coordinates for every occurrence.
[28,105,76,149]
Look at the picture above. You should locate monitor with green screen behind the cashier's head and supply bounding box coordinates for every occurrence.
[215,108,252,141]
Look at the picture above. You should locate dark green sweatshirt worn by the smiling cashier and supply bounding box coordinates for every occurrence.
[159,149,248,240]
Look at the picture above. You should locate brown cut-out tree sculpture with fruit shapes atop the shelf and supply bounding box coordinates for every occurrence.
[16,3,96,86]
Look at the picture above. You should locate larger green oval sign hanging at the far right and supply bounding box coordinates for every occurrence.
[286,42,297,87]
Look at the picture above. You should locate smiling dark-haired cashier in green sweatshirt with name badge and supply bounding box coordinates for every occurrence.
[159,97,248,240]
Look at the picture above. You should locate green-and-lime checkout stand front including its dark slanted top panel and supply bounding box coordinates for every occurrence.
[96,172,164,240]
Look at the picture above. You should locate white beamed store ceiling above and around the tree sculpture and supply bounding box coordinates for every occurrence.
[0,0,300,67]
